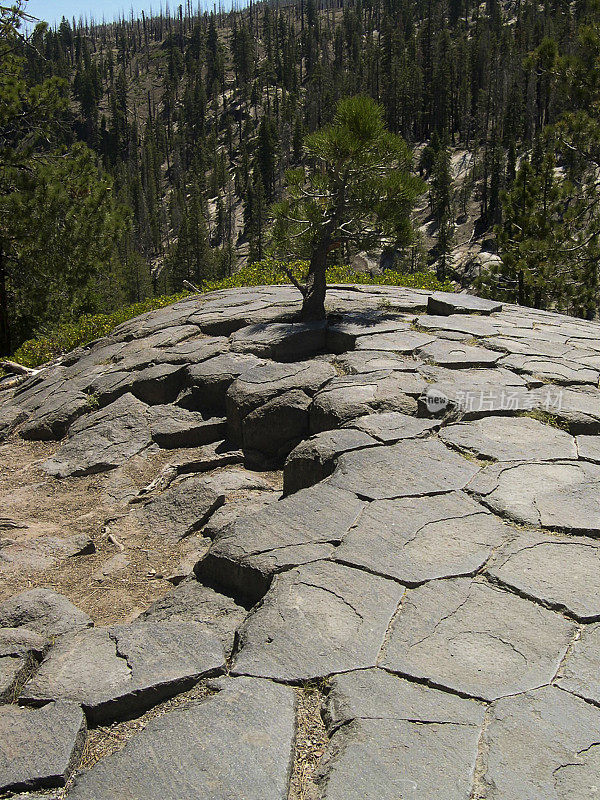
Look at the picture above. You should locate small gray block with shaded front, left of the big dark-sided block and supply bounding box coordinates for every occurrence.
[149,405,227,448]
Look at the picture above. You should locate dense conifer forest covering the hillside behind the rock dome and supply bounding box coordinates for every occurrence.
[0,0,600,354]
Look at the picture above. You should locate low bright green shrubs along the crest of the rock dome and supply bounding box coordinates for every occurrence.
[13,259,452,367]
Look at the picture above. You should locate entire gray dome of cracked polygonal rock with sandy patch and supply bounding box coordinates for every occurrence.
[0,286,600,800]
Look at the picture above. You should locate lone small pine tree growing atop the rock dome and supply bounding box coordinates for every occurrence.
[272,96,424,320]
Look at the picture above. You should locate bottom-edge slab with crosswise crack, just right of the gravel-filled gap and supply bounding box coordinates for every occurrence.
[317,670,484,800]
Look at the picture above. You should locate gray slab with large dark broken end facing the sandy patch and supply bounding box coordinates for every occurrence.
[195,484,364,604]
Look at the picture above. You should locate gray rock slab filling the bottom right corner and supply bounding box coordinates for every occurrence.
[477,686,600,800]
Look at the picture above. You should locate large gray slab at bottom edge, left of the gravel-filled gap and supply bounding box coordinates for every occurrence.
[69,678,295,800]
